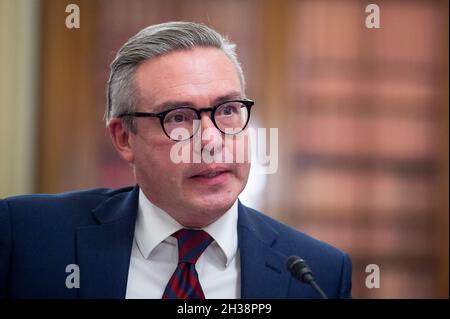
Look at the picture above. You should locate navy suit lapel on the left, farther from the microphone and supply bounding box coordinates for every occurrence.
[77,186,139,298]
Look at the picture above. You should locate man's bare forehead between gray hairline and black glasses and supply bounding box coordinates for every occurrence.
[135,48,242,112]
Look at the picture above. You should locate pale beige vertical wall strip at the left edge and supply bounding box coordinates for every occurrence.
[0,0,39,197]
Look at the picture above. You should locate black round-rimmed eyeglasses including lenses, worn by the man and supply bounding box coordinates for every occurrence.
[118,100,255,141]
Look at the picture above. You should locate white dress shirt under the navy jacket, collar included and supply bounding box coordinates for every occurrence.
[126,190,241,299]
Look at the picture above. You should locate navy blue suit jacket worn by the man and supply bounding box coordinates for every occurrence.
[0,186,351,298]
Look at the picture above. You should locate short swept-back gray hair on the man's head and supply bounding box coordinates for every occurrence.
[105,22,245,132]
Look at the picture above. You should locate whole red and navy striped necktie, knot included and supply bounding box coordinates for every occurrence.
[163,229,214,299]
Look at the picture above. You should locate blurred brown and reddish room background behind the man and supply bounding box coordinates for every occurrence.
[0,0,449,298]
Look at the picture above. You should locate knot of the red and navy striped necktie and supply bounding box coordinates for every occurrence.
[172,228,213,264]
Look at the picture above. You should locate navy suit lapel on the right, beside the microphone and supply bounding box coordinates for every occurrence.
[238,203,290,299]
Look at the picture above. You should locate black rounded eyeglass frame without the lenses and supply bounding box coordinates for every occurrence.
[117,99,255,142]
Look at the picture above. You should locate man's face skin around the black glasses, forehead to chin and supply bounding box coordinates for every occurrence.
[115,48,250,227]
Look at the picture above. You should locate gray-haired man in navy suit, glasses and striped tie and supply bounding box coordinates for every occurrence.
[0,22,351,298]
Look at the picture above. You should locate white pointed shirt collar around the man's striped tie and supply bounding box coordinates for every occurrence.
[135,189,238,266]
